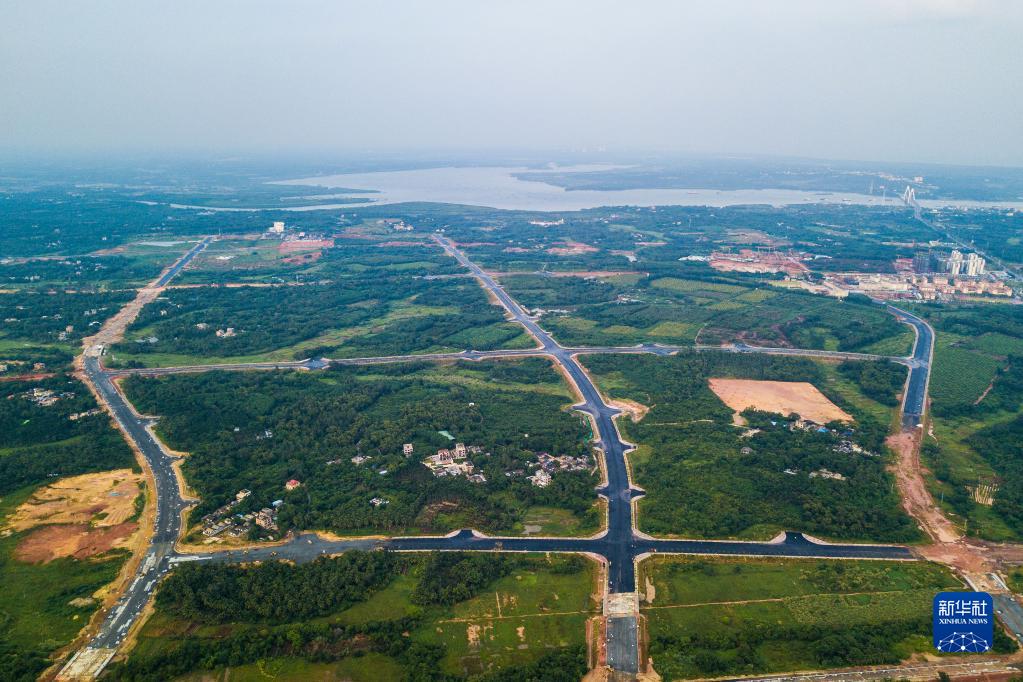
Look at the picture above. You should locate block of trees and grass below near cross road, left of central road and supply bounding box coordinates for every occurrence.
[103,552,599,682]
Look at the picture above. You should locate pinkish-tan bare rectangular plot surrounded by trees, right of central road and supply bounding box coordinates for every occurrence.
[708,379,852,424]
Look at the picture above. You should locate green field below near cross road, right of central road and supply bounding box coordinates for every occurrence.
[639,557,965,679]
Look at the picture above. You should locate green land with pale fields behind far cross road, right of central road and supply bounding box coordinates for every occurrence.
[502,266,911,355]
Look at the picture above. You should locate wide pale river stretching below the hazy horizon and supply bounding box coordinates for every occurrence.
[178,166,1023,211]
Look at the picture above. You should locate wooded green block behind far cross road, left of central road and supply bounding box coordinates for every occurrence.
[112,276,523,364]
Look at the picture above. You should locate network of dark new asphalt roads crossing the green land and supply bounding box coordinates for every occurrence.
[61,236,933,679]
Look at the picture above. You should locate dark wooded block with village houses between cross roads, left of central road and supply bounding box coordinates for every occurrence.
[124,359,602,535]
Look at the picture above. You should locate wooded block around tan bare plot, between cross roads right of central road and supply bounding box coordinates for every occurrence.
[582,352,920,542]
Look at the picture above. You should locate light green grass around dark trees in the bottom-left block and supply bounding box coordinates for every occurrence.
[118,555,599,682]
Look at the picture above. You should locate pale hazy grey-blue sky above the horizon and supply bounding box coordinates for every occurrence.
[0,0,1023,166]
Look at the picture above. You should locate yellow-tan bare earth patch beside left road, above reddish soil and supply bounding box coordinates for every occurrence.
[7,469,142,532]
